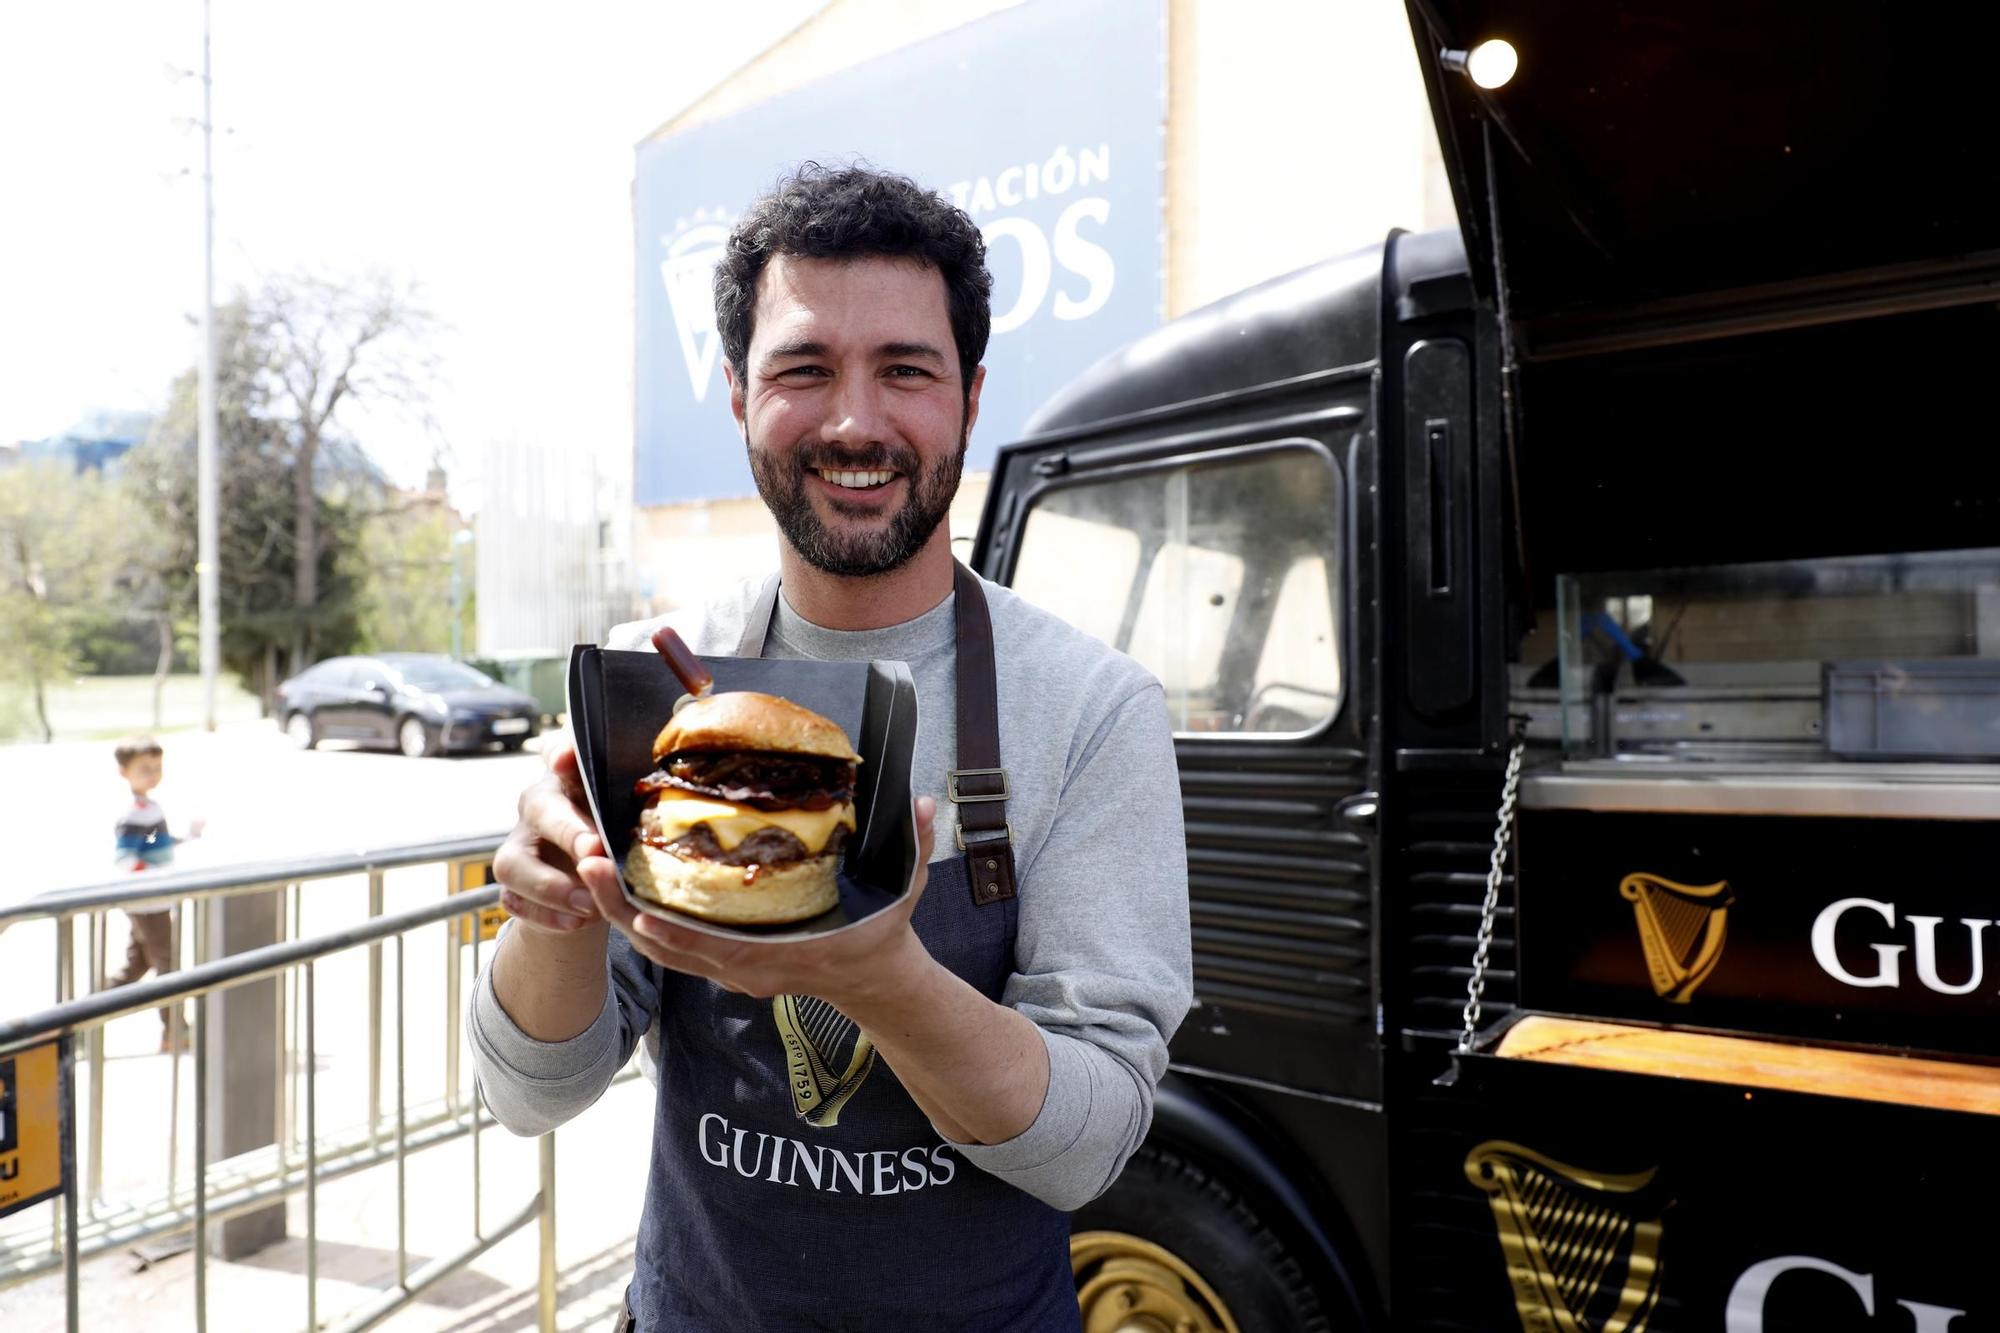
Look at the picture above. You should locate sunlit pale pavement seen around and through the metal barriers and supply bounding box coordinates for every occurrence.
[0,723,652,1333]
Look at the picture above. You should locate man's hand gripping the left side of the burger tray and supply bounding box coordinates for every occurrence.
[494,735,618,935]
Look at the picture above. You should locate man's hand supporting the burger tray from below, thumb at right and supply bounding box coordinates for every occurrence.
[590,797,936,1000]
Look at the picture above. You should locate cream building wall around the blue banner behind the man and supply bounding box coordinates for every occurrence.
[628,0,1454,612]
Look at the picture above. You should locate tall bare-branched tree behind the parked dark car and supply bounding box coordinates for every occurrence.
[248,274,436,673]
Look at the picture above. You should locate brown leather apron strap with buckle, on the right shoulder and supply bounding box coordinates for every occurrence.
[944,560,1014,907]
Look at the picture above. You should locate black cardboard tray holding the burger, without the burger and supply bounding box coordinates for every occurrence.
[568,644,918,941]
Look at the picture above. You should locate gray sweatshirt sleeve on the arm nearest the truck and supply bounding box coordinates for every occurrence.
[954,683,1194,1211]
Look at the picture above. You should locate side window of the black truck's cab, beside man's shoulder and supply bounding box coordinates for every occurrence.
[1012,442,1342,735]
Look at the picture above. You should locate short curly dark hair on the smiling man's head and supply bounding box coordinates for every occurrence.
[716,162,994,394]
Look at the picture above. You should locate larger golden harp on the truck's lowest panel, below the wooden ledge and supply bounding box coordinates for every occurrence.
[1466,1139,1660,1333]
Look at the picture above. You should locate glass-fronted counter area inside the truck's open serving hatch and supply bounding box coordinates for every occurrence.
[1514,548,2000,756]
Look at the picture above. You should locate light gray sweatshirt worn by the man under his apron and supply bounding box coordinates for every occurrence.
[468,568,1192,1209]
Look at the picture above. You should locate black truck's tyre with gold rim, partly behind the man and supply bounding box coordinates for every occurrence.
[1070,1143,1334,1333]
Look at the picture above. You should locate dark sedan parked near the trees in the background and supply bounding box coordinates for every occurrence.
[278,652,542,759]
